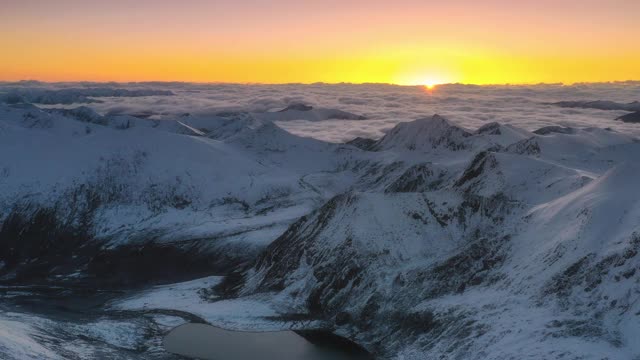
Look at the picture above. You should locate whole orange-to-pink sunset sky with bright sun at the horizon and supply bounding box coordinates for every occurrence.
[0,0,640,84]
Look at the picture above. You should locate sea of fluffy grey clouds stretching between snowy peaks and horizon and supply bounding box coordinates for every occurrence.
[0,82,640,142]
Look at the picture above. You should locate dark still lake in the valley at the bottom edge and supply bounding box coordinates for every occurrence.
[164,324,372,360]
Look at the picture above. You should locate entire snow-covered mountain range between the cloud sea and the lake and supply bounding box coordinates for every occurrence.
[0,104,640,359]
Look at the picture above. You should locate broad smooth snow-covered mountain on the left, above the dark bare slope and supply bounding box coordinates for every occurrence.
[0,105,357,286]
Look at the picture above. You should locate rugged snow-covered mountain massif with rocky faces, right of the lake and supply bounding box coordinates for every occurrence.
[219,117,640,359]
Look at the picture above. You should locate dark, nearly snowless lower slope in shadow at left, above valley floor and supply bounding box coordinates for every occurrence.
[0,208,238,288]
